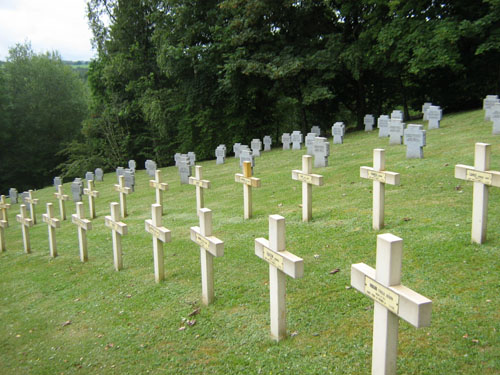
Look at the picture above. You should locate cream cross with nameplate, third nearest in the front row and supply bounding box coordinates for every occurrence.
[191,208,224,305]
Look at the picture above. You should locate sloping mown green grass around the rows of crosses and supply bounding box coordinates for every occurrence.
[0,111,500,374]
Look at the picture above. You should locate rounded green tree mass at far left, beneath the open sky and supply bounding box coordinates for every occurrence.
[0,44,88,194]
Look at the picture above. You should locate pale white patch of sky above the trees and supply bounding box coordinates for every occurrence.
[0,0,95,61]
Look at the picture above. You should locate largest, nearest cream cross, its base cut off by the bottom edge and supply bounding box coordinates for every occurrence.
[351,233,432,375]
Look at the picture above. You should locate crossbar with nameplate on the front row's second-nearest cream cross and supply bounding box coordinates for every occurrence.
[255,238,304,279]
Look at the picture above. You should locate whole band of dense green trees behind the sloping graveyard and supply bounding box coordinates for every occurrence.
[0,0,500,193]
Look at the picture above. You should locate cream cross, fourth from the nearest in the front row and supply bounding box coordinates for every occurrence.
[146,204,170,283]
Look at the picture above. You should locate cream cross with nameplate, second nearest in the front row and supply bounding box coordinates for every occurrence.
[255,215,304,341]
